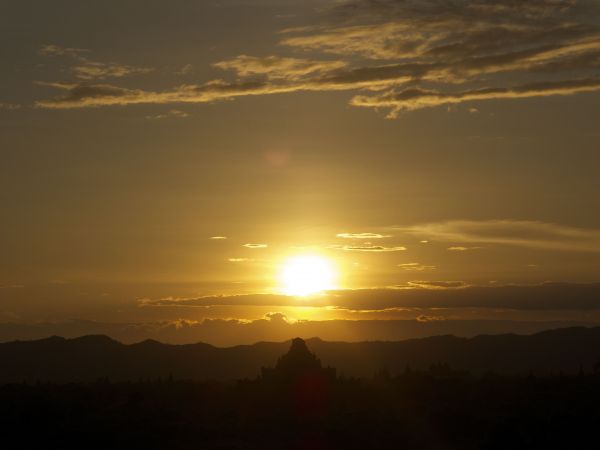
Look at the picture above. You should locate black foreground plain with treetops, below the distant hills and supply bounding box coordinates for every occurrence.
[0,366,600,449]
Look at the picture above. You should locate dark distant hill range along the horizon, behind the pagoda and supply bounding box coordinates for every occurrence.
[0,327,600,383]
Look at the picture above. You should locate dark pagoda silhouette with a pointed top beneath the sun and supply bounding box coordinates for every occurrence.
[261,338,336,384]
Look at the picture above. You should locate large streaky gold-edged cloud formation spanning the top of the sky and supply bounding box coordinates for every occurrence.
[37,0,600,117]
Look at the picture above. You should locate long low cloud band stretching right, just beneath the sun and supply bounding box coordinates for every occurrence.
[139,280,600,311]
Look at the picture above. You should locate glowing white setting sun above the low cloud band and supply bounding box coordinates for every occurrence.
[279,255,336,296]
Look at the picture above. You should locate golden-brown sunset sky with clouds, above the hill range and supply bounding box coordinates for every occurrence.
[0,0,600,345]
